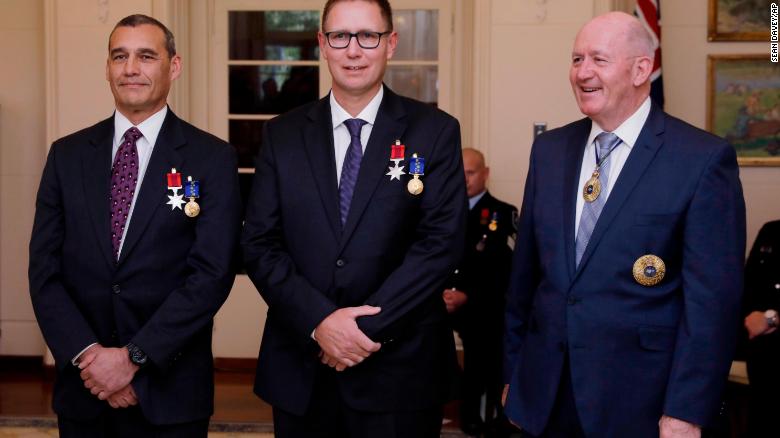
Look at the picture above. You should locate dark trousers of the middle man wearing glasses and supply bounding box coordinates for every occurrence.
[273,369,443,438]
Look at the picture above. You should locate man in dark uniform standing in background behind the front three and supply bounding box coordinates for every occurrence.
[442,148,517,437]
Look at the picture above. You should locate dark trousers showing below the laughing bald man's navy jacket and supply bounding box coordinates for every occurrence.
[523,355,585,438]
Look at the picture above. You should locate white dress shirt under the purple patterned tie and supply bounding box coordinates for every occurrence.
[111,105,168,254]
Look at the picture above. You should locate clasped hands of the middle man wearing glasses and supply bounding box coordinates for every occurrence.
[314,305,382,371]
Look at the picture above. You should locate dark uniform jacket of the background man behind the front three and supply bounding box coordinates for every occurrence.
[447,192,517,338]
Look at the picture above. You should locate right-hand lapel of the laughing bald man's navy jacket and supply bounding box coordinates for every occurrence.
[577,105,664,275]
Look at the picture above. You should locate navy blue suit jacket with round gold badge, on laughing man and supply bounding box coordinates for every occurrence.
[505,102,745,437]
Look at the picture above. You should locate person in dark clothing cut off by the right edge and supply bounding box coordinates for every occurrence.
[744,221,780,437]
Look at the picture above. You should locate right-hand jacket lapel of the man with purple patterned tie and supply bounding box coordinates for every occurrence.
[118,108,184,264]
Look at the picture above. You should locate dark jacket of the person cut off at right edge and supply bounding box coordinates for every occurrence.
[743,221,780,386]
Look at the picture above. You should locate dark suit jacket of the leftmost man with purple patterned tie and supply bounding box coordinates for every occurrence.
[29,110,241,424]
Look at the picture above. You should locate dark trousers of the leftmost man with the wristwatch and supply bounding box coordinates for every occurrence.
[57,406,209,438]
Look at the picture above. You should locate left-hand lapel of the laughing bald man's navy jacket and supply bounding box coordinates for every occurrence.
[563,119,591,278]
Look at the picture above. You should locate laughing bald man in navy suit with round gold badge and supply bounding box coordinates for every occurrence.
[504,12,745,437]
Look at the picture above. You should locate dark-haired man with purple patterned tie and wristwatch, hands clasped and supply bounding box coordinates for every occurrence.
[29,15,241,437]
